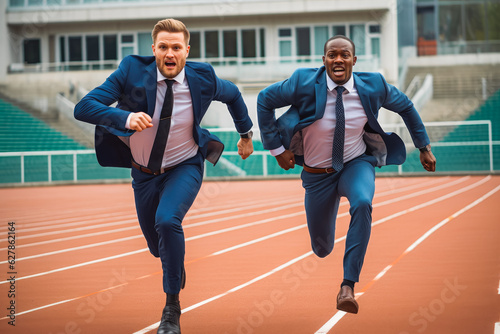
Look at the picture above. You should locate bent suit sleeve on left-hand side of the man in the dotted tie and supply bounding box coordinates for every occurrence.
[257,72,298,150]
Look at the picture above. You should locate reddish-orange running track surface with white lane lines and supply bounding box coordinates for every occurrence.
[0,176,500,334]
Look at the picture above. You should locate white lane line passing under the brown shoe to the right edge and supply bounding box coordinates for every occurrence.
[315,186,500,334]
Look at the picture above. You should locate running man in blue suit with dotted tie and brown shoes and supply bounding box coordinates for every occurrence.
[257,35,436,313]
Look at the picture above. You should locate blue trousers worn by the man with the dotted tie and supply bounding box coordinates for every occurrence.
[301,154,377,282]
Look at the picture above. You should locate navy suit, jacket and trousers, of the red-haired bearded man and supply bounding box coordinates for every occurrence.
[75,56,252,294]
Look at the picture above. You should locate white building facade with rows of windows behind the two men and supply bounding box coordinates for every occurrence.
[0,0,398,82]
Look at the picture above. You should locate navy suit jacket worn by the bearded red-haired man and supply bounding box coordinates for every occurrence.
[75,56,252,168]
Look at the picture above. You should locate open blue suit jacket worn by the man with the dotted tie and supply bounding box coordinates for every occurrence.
[257,66,429,166]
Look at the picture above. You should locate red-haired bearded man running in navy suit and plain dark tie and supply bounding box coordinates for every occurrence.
[75,19,253,334]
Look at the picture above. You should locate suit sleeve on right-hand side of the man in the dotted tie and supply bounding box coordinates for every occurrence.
[381,76,430,148]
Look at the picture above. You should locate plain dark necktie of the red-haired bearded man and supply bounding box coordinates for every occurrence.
[148,79,174,172]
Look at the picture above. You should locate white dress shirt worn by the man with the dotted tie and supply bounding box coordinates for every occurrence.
[271,73,368,168]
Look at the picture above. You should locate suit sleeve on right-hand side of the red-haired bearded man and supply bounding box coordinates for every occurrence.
[212,69,253,133]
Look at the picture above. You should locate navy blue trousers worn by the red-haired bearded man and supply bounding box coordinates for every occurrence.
[132,153,204,294]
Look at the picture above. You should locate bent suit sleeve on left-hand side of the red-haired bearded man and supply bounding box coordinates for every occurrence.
[74,58,133,136]
